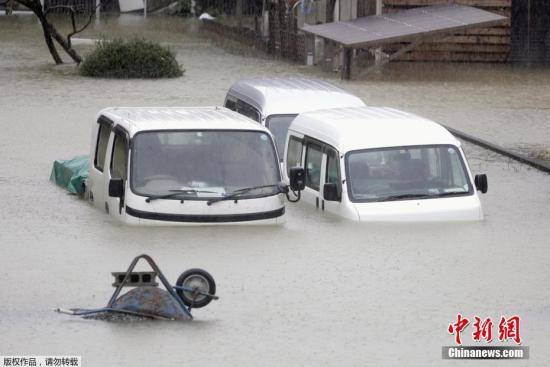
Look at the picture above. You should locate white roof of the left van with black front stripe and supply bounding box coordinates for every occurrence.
[98,107,268,136]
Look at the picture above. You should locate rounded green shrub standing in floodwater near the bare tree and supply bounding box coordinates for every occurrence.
[79,38,184,79]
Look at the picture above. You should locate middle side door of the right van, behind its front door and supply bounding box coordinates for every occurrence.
[302,140,325,208]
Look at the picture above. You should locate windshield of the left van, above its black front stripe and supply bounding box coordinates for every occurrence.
[130,130,281,200]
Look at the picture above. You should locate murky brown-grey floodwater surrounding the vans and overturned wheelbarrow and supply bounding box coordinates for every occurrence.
[0,15,550,366]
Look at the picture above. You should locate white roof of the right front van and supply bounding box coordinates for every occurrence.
[289,107,460,153]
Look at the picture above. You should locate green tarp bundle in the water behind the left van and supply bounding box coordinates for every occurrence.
[50,155,90,194]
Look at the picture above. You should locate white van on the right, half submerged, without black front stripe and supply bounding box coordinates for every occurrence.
[284,107,487,221]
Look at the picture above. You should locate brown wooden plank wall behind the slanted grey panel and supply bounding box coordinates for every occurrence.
[384,0,512,62]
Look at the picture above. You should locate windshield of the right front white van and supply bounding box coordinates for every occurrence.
[346,145,473,202]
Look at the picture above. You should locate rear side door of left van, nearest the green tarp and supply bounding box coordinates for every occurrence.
[88,116,113,210]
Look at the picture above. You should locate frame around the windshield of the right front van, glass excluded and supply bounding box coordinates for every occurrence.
[344,144,475,203]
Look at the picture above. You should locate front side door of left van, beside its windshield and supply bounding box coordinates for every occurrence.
[105,126,129,219]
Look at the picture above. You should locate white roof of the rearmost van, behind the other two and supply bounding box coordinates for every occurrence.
[228,78,365,117]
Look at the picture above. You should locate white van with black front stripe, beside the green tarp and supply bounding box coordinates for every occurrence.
[86,107,308,224]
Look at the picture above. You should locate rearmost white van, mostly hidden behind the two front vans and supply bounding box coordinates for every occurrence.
[224,78,365,159]
